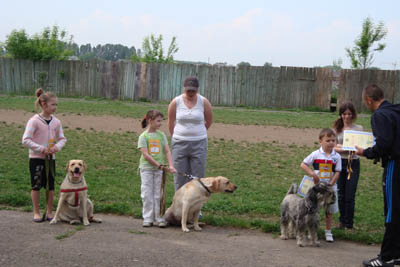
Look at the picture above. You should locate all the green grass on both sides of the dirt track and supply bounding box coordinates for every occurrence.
[0,96,383,243]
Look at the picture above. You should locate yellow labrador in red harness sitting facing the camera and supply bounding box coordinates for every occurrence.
[50,159,101,225]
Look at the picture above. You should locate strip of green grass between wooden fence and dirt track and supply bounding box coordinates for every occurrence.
[0,95,370,129]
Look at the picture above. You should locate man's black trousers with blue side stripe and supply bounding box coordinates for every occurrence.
[381,160,400,261]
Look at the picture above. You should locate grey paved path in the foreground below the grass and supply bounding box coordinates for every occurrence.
[0,210,379,267]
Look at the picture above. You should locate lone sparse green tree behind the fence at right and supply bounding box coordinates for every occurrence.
[346,17,387,69]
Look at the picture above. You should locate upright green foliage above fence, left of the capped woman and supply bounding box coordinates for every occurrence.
[131,34,179,63]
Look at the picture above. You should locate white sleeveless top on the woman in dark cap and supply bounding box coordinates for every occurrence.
[172,94,207,141]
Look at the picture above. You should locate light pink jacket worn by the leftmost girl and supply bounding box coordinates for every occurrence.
[22,114,67,159]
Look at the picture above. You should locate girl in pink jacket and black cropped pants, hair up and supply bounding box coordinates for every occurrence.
[22,88,67,222]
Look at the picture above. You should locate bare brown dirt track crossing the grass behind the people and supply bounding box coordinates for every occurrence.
[0,109,319,146]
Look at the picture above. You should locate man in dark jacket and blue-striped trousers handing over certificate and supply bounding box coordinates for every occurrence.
[356,84,400,266]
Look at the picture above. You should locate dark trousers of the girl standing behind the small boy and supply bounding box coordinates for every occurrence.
[337,159,360,228]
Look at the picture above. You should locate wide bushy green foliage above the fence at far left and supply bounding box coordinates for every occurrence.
[4,26,72,61]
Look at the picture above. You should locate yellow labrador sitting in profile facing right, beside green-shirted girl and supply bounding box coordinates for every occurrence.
[165,176,237,232]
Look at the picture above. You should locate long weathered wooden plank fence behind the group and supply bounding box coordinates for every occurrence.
[0,58,400,109]
